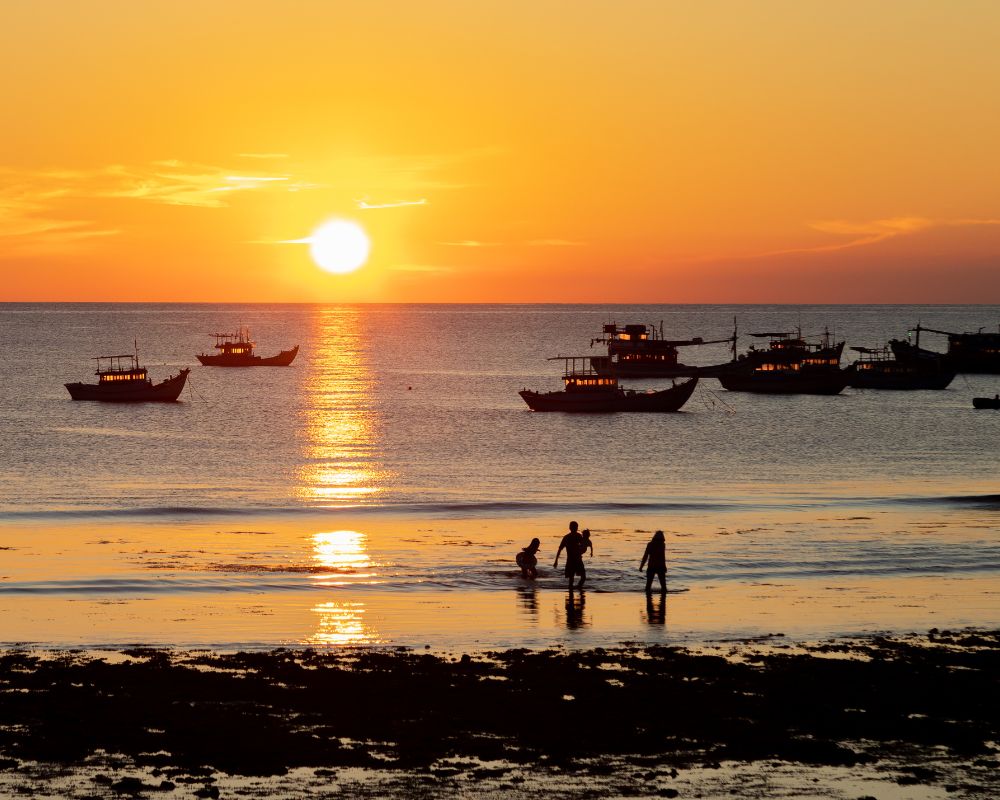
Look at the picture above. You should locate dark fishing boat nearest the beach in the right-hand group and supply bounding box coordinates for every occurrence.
[519,356,698,413]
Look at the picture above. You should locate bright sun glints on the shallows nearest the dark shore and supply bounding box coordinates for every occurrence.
[306,530,380,646]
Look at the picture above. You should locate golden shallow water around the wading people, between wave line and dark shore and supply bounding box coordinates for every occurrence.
[7,507,1000,653]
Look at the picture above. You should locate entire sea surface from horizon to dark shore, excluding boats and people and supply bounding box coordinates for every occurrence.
[0,304,1000,648]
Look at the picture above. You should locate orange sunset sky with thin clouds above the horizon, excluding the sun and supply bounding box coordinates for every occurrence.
[0,0,1000,303]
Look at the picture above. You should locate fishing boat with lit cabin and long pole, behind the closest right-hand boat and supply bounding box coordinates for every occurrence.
[590,322,729,378]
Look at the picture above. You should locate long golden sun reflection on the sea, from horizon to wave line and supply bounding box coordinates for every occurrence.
[299,309,386,504]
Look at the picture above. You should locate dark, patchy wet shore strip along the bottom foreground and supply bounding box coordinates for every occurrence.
[0,630,1000,798]
